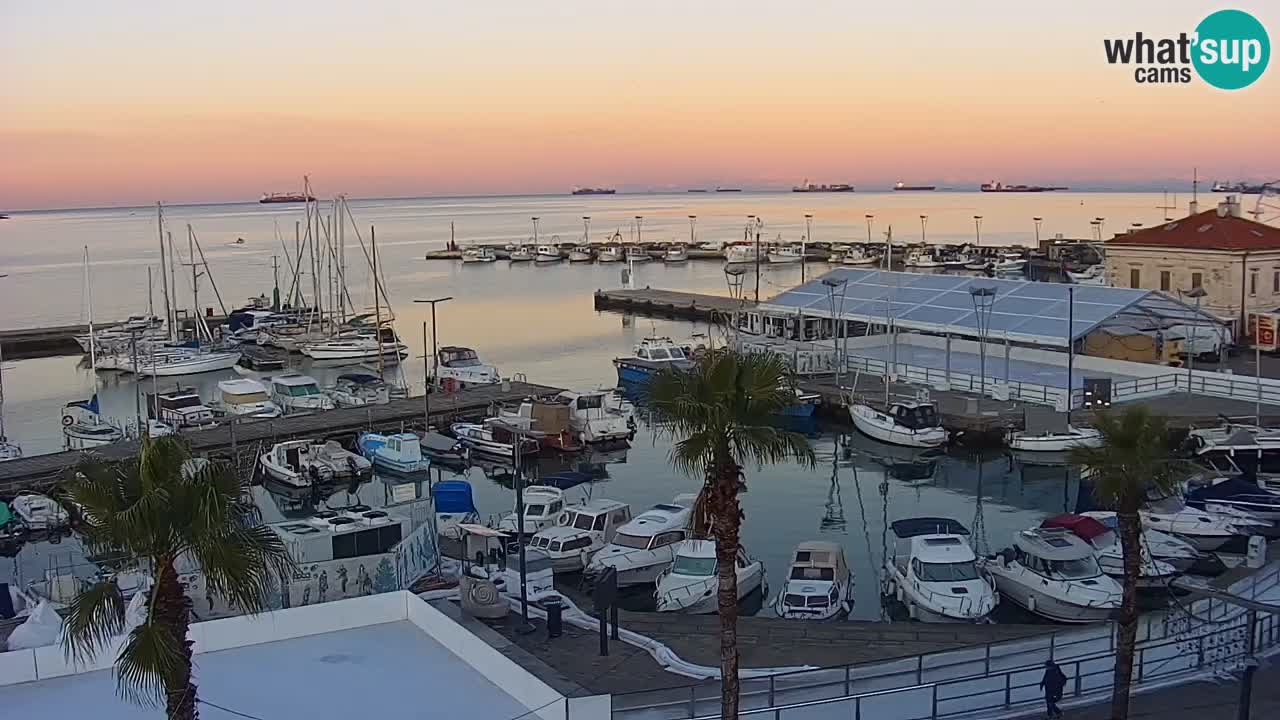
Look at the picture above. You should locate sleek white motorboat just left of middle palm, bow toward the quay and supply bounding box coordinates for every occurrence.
[586,495,698,587]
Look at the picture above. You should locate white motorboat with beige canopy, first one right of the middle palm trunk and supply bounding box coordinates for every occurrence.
[773,541,854,620]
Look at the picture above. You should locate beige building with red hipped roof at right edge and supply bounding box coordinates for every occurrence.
[1106,196,1280,337]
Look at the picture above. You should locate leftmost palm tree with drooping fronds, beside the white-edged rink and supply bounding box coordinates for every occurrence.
[63,437,293,720]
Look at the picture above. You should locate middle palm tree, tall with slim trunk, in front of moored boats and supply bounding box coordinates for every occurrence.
[649,350,814,720]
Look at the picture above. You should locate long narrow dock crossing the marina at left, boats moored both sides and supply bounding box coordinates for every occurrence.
[0,382,561,496]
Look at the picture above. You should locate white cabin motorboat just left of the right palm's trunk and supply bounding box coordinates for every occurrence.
[979,528,1123,623]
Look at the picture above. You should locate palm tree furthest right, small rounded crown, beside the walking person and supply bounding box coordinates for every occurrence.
[1070,405,1187,720]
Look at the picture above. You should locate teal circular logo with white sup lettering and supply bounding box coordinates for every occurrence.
[1192,10,1271,90]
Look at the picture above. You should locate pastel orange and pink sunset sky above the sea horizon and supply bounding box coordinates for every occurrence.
[0,0,1280,209]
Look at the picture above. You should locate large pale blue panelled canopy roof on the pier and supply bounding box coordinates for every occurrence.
[759,268,1221,347]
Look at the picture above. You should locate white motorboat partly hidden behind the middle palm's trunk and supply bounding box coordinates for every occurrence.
[654,539,768,615]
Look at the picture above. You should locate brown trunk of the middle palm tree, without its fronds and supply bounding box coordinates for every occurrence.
[710,461,742,720]
